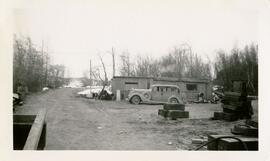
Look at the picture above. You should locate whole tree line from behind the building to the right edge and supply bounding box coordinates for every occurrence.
[120,44,258,94]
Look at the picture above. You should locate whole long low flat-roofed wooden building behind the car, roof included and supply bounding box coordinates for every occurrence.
[111,76,212,101]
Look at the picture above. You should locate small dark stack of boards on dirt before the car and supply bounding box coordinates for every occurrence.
[158,103,189,120]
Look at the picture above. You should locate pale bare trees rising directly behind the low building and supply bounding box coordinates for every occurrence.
[120,44,212,79]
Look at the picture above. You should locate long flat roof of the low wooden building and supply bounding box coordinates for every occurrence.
[113,76,210,83]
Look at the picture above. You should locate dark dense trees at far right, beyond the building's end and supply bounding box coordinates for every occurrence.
[214,44,258,94]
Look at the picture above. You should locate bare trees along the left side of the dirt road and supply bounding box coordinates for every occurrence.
[13,35,66,92]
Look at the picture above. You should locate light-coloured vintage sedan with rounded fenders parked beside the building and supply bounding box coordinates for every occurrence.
[128,84,183,104]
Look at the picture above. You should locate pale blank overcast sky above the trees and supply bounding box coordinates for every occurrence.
[13,0,259,77]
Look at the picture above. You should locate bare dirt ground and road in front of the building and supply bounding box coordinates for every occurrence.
[15,88,258,150]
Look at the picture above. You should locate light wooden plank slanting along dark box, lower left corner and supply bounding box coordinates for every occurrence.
[23,109,46,150]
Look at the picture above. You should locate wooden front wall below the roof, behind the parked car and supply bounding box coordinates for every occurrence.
[112,77,211,101]
